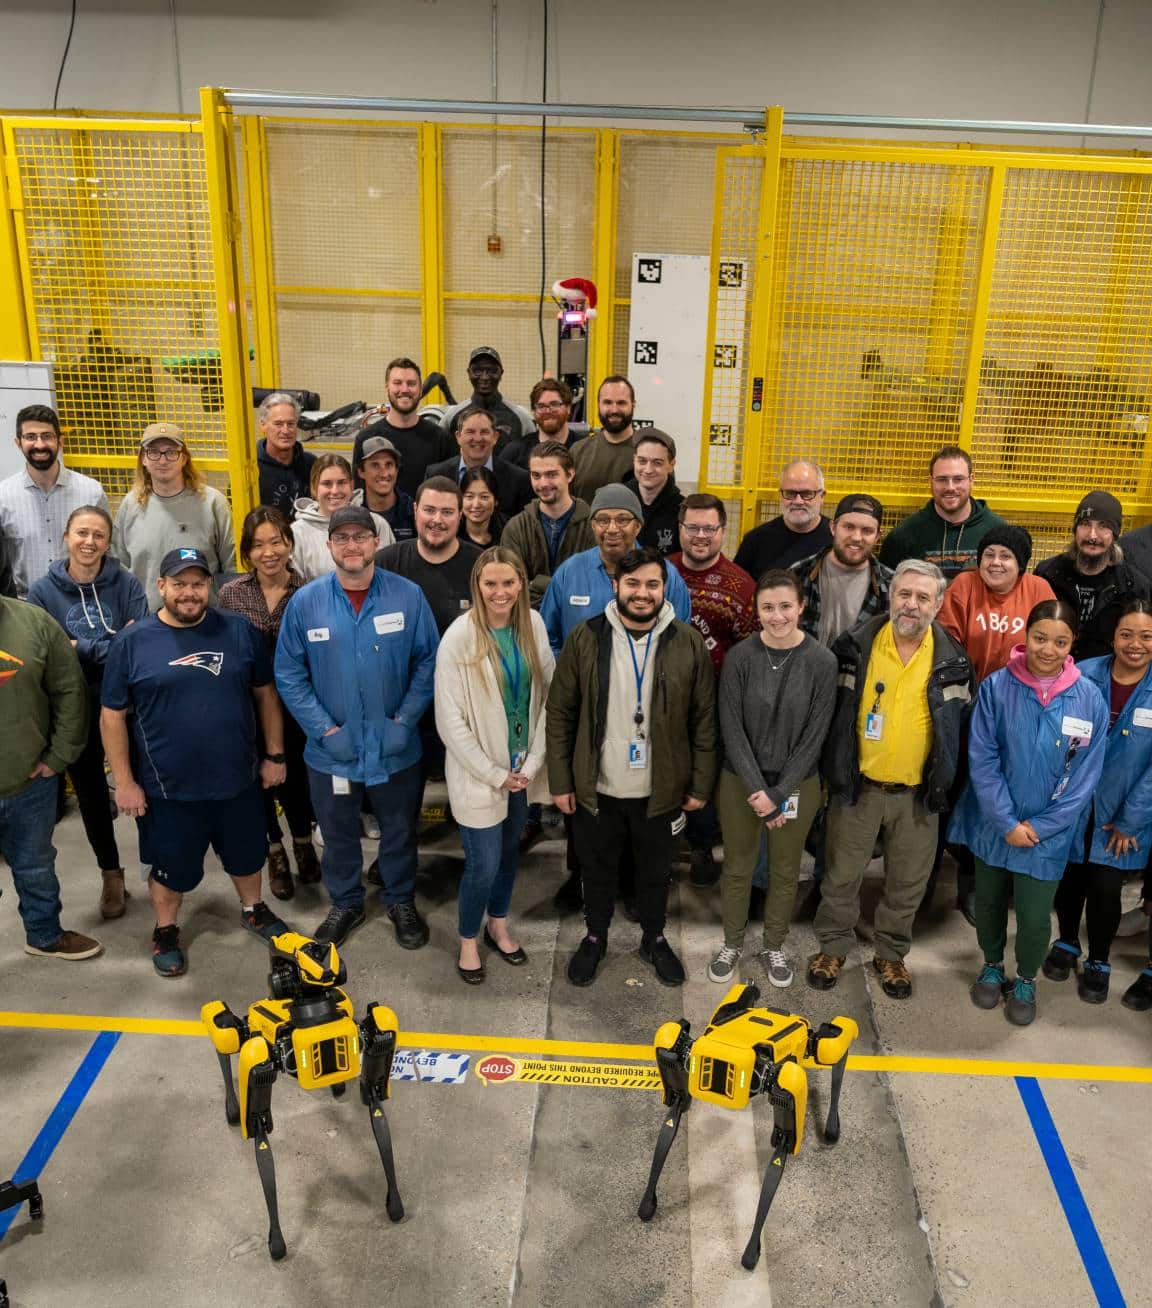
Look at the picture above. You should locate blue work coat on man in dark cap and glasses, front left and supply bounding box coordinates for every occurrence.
[276,568,439,786]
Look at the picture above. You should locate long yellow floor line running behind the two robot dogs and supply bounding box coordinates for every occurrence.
[0,1011,1152,1086]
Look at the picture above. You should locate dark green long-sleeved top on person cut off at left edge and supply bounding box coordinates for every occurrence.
[0,599,88,797]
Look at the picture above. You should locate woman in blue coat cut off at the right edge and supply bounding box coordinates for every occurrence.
[1043,599,1152,1003]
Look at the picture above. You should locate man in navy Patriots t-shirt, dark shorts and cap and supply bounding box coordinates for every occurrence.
[101,549,288,977]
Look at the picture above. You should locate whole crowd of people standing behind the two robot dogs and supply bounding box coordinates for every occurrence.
[0,361,1152,1024]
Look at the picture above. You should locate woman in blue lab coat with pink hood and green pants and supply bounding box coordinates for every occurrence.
[948,599,1108,1027]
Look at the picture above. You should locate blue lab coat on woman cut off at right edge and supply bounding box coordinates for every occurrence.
[1070,654,1152,871]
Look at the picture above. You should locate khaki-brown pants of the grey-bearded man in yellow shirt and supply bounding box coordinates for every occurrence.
[813,781,940,959]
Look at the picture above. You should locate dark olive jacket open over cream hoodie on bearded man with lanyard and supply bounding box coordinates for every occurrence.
[548,613,718,818]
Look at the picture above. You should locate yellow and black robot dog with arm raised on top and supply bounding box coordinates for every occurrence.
[200,931,404,1260]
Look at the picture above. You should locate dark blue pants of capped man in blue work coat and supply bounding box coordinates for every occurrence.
[309,763,424,908]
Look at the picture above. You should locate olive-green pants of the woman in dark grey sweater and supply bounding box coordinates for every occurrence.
[717,768,820,950]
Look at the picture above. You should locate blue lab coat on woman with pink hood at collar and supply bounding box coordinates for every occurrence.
[948,667,1109,882]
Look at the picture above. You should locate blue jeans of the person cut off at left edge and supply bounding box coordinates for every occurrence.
[0,777,61,948]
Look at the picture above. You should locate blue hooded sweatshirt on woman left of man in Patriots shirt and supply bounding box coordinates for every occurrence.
[27,555,148,685]
